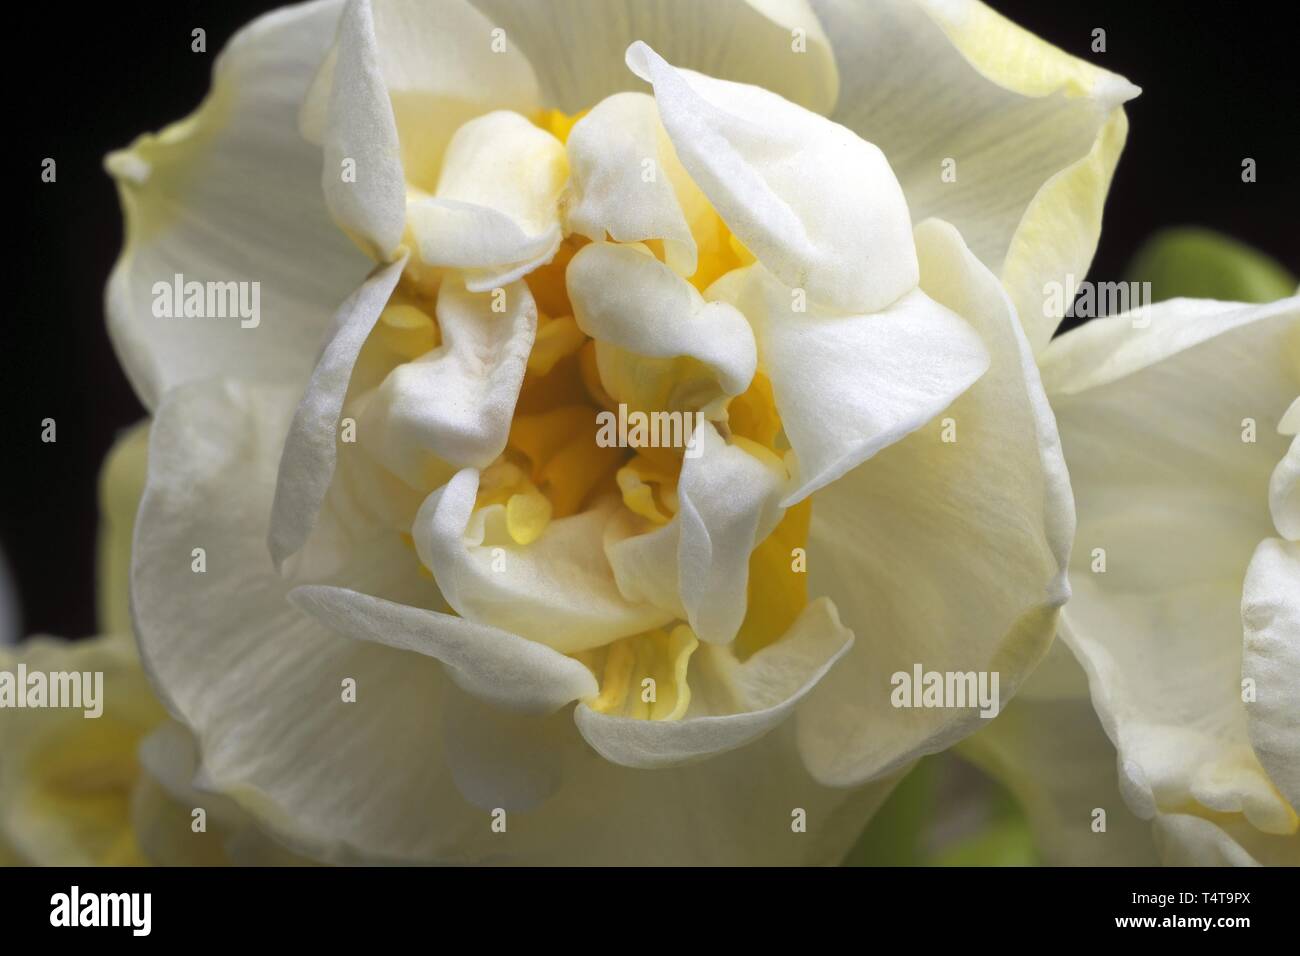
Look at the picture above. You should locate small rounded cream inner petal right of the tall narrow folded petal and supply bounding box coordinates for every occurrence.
[407,111,568,291]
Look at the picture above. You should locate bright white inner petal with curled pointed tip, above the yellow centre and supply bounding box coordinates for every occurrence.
[628,42,917,312]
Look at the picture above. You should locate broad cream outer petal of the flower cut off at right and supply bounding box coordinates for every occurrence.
[1041,299,1300,832]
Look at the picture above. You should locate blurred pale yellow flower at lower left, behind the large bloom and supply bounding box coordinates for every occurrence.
[0,427,306,866]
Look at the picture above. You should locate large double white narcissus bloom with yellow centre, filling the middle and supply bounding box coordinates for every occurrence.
[108,0,1136,862]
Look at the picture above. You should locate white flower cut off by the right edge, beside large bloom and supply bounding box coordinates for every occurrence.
[971,297,1300,865]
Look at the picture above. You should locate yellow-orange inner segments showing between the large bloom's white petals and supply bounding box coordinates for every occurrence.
[363,111,811,719]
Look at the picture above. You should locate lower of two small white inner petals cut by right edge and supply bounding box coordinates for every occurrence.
[1242,538,1300,809]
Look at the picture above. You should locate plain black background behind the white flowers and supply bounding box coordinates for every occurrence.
[0,0,1300,636]
